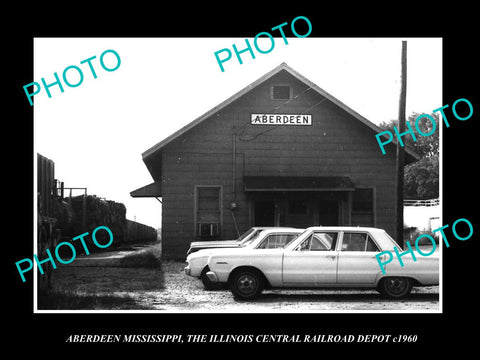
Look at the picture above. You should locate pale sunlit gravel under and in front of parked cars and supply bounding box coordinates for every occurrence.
[130,262,440,313]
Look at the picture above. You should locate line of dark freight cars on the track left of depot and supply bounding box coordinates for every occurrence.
[36,154,157,289]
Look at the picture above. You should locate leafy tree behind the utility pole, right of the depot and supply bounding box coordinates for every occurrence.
[379,113,440,200]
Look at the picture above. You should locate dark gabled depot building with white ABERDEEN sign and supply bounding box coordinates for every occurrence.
[130,63,417,259]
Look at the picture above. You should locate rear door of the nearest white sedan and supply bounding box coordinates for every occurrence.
[337,231,380,284]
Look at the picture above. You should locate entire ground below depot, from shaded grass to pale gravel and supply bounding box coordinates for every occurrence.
[45,245,441,313]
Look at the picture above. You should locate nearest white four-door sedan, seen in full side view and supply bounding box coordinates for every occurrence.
[205,226,439,300]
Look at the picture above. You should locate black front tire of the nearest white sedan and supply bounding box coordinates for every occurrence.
[229,269,264,301]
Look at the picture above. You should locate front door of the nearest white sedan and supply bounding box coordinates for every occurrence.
[282,231,338,287]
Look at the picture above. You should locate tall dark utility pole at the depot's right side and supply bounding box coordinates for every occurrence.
[396,41,407,248]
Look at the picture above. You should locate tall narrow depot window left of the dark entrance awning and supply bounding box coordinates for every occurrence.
[195,186,221,239]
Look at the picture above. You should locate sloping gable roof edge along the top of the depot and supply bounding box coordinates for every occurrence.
[142,63,419,161]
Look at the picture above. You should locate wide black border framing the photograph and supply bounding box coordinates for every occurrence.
[8,3,480,356]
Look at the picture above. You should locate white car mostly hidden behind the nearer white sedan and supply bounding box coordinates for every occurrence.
[184,228,304,290]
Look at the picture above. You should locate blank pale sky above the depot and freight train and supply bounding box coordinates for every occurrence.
[32,37,444,228]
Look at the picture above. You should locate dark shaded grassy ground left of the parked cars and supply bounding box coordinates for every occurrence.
[37,243,165,310]
